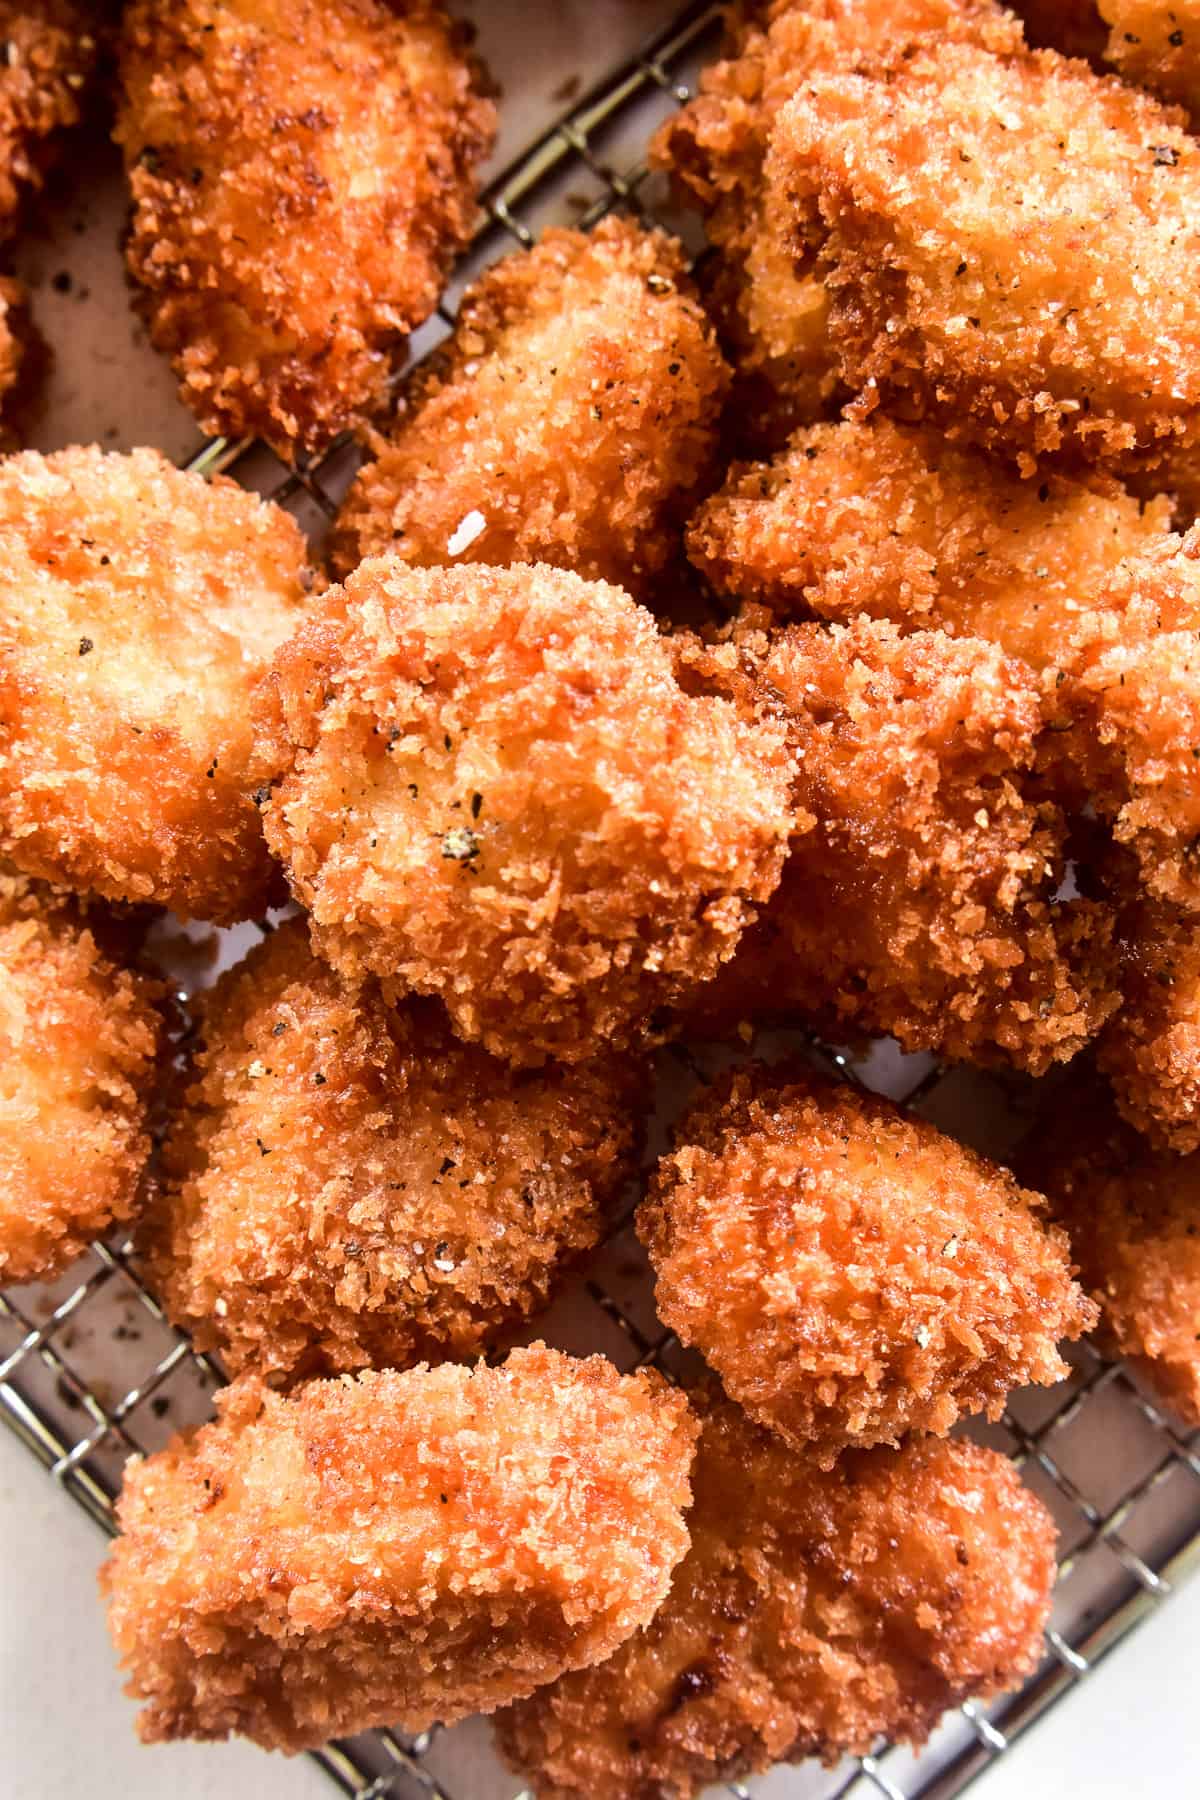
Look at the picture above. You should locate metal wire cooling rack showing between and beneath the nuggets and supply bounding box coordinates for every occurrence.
[0,5,1200,1800]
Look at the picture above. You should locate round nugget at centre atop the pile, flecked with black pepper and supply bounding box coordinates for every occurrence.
[259,556,790,1062]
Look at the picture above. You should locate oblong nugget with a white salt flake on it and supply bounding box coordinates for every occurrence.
[333,218,729,601]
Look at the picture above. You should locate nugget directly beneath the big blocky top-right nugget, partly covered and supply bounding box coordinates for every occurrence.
[687,414,1171,670]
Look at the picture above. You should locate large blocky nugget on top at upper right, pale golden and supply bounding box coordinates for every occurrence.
[772,40,1200,470]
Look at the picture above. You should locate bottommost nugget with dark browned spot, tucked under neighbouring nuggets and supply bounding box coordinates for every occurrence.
[497,1402,1054,1800]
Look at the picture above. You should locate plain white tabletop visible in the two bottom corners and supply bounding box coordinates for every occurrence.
[0,1431,1200,1800]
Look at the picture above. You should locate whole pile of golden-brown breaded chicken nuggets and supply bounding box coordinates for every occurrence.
[0,0,1200,1800]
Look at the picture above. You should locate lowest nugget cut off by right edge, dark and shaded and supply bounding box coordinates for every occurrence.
[1022,1085,1200,1426]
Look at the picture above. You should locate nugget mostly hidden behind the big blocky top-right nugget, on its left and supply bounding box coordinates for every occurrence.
[649,0,1020,443]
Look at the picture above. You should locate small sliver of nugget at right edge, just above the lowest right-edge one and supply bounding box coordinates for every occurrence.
[1097,900,1200,1152]
